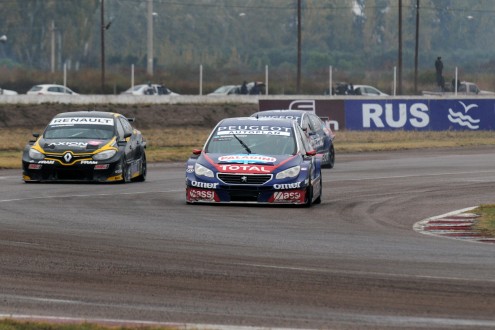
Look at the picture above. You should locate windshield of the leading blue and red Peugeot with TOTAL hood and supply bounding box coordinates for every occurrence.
[205,131,296,155]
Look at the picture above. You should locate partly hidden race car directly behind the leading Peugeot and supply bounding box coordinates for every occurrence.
[251,110,335,168]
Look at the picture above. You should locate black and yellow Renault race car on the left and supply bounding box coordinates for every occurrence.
[22,111,146,183]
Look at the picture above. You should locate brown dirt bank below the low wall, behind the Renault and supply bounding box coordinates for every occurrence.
[0,103,258,129]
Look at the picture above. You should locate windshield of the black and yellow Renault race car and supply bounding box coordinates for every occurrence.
[43,125,115,140]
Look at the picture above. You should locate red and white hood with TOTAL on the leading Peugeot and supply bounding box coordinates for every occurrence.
[199,154,300,174]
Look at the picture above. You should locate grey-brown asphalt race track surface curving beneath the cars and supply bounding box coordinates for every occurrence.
[0,147,495,329]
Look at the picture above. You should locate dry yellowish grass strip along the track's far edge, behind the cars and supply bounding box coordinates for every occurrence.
[5,128,495,168]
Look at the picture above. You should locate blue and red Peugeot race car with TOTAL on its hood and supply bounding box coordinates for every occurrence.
[186,117,322,207]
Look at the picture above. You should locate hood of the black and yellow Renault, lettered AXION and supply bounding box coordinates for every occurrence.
[38,138,114,153]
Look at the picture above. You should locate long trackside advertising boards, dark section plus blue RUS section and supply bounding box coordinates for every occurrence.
[259,98,495,131]
